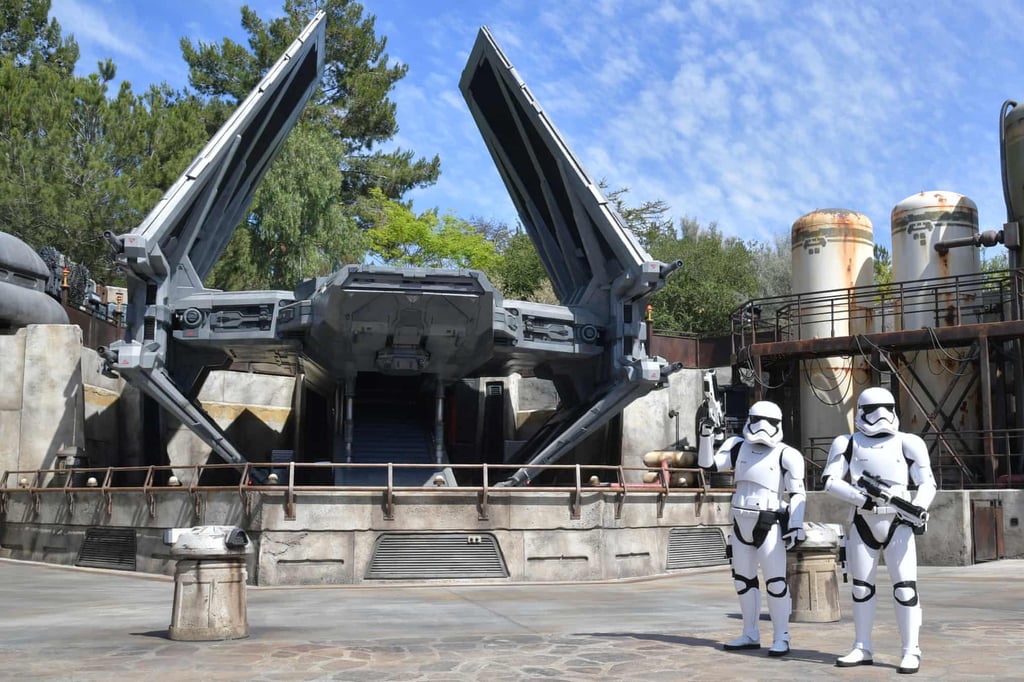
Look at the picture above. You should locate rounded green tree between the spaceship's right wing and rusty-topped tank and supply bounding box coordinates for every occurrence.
[650,218,759,335]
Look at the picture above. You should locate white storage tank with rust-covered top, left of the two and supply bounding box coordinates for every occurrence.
[791,209,874,465]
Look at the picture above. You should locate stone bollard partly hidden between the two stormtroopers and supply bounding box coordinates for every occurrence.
[786,523,842,623]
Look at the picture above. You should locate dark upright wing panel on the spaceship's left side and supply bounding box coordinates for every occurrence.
[133,12,326,280]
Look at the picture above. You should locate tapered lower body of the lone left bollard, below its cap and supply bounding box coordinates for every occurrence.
[168,557,249,641]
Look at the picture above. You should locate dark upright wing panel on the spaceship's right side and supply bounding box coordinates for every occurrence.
[460,28,651,305]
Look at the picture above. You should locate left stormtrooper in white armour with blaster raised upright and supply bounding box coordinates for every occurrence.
[697,400,807,656]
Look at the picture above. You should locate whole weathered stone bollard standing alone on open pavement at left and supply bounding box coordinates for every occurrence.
[164,525,251,641]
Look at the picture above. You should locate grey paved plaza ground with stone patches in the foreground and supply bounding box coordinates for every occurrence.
[0,559,1024,682]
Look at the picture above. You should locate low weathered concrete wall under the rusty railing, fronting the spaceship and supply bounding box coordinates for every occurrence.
[0,487,729,585]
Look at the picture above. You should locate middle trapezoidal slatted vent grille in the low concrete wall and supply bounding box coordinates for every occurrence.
[367,532,509,580]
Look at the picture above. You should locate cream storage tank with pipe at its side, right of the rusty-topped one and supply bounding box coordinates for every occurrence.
[892,191,981,462]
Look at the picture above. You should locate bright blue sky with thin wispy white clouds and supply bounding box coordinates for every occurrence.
[52,0,1024,253]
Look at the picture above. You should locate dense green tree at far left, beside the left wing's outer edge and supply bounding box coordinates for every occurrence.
[0,1,218,284]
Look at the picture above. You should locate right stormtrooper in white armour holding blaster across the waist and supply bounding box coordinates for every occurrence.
[822,388,936,673]
